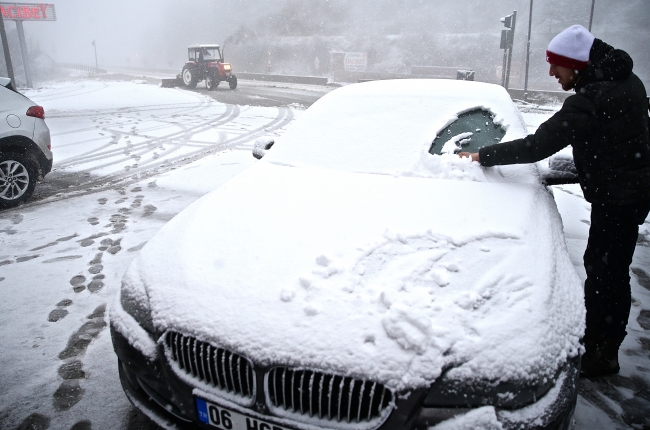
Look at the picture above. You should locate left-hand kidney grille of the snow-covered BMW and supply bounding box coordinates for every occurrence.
[165,332,255,400]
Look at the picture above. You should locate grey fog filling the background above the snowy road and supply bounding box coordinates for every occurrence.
[0,0,650,89]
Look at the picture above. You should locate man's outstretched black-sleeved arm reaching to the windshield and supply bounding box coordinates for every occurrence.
[459,96,597,167]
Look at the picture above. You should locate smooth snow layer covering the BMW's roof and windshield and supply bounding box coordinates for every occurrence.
[265,79,527,180]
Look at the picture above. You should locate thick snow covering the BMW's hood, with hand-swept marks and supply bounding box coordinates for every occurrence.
[123,162,584,390]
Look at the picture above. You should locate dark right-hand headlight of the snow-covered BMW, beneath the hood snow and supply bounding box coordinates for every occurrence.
[424,362,564,409]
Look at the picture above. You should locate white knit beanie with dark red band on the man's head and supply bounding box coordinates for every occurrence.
[546,25,595,70]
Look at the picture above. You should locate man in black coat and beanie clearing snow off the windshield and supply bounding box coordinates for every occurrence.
[460,25,650,377]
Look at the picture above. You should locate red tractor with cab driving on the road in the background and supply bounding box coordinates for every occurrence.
[181,45,237,90]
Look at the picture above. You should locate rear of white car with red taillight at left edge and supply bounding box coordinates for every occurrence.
[0,78,52,208]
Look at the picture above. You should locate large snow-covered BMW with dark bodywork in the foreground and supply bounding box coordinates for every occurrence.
[110,80,585,430]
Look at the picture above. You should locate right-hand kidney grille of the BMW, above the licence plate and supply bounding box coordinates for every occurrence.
[266,367,393,423]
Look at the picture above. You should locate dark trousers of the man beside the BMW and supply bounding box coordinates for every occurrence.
[584,201,650,350]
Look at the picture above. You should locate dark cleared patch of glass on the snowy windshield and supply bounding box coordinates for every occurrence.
[429,109,506,155]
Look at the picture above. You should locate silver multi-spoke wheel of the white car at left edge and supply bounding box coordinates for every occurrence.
[0,152,37,208]
